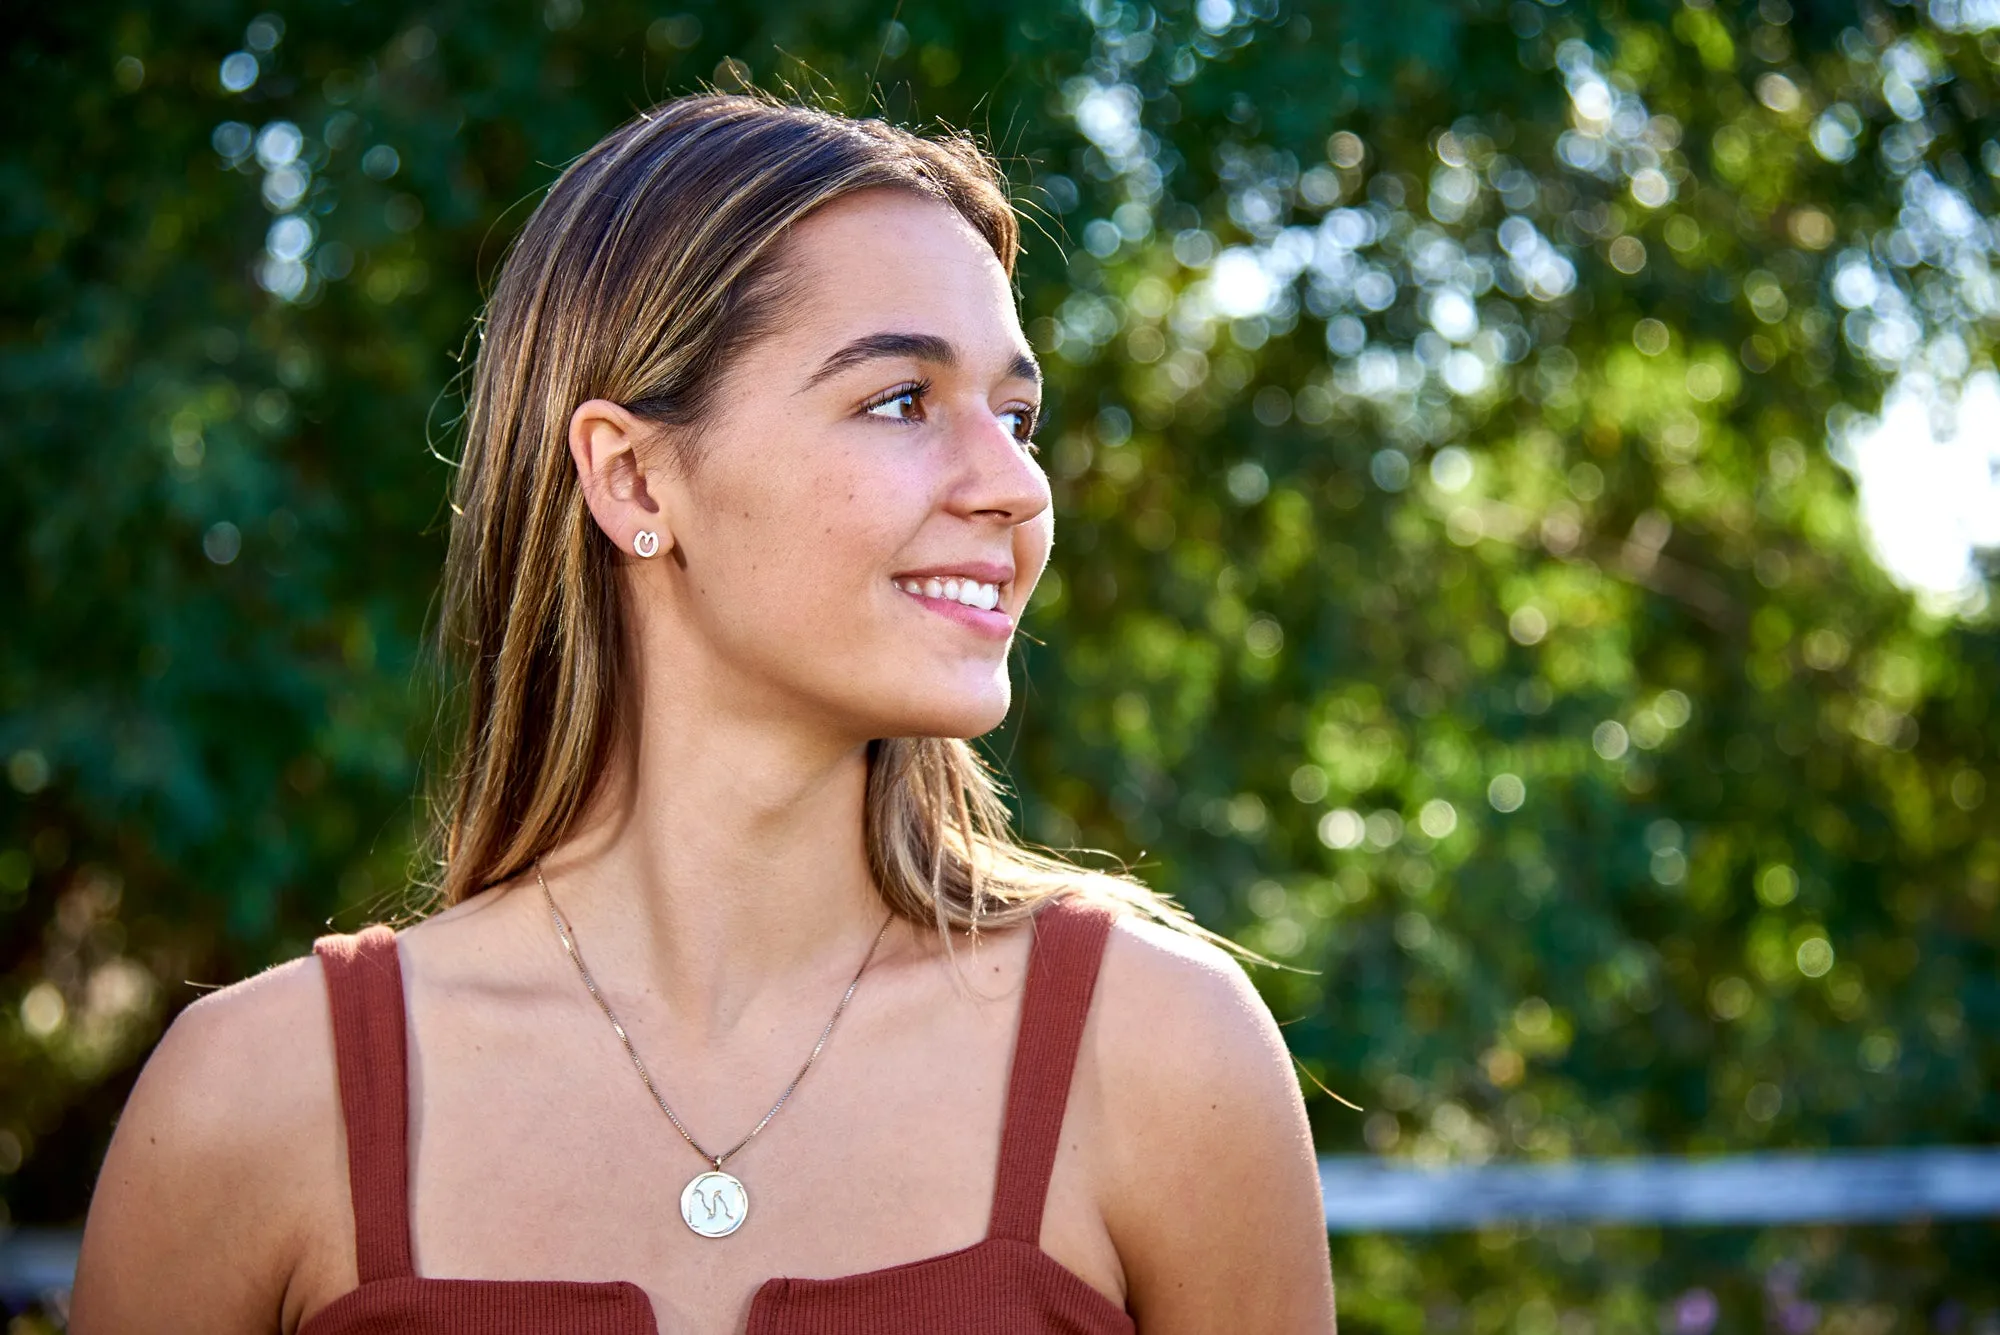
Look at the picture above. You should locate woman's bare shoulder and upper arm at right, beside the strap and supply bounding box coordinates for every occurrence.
[1096,917,1334,1335]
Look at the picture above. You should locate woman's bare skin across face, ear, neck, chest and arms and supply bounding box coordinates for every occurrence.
[72,190,1334,1335]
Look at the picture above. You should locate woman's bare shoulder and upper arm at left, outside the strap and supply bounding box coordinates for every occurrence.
[70,955,338,1335]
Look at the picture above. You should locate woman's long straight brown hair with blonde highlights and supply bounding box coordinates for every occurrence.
[430,90,1254,957]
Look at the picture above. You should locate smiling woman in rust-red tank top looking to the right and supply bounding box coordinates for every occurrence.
[72,96,1334,1335]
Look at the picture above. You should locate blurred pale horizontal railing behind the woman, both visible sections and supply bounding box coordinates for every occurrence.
[0,1147,2000,1303]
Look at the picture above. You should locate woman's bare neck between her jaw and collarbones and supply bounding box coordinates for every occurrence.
[528,679,906,1039]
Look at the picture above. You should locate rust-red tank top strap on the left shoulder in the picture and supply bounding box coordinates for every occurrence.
[312,923,414,1283]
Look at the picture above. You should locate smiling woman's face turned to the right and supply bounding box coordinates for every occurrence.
[572,190,1052,741]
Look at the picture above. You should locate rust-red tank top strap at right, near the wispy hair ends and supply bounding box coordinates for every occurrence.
[986,895,1116,1247]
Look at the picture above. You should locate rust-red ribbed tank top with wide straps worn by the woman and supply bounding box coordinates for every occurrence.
[298,897,1136,1335]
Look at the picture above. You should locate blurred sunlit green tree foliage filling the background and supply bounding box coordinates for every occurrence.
[0,0,2000,1331]
